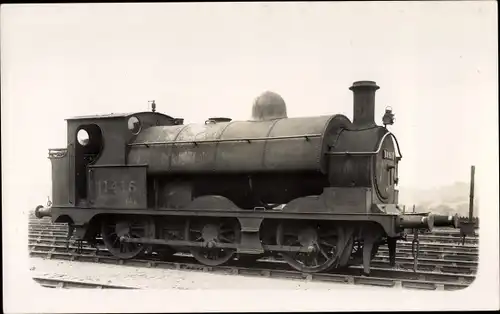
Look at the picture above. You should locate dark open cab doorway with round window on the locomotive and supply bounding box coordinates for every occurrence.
[75,124,104,205]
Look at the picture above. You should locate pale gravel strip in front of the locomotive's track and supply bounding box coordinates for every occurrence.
[31,258,382,290]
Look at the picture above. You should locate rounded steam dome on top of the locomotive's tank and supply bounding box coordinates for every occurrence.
[252,91,287,121]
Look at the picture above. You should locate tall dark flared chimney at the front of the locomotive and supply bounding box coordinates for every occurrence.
[349,81,380,128]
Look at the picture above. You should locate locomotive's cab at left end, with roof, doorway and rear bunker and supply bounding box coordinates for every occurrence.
[49,112,183,211]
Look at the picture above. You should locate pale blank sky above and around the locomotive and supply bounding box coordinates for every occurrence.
[1,1,498,210]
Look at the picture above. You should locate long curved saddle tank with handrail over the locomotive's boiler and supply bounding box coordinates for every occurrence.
[128,115,349,174]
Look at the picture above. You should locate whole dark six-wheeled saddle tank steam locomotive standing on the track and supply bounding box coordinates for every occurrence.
[36,81,457,273]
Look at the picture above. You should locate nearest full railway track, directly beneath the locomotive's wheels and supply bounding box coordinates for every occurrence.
[30,246,475,290]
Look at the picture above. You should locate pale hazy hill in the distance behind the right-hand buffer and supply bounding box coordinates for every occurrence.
[399,182,479,217]
